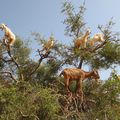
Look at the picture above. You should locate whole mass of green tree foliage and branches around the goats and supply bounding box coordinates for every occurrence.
[0,1,120,120]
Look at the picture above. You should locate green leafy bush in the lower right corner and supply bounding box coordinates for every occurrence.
[85,73,120,120]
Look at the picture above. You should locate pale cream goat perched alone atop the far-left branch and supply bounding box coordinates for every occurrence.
[0,24,15,51]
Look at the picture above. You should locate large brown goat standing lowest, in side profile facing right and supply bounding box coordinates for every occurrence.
[60,68,100,94]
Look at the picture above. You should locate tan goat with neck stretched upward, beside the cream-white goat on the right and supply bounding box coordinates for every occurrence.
[74,30,91,49]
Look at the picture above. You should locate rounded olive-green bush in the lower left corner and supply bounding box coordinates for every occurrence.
[0,82,59,120]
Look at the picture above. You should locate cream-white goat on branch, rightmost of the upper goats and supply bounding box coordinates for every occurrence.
[88,33,105,47]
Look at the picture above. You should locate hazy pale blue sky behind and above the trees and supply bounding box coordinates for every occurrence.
[0,0,120,79]
